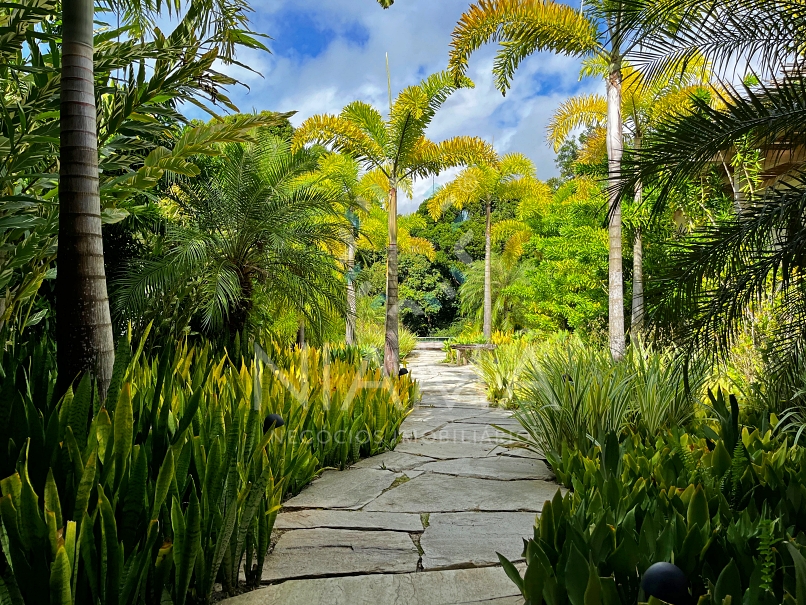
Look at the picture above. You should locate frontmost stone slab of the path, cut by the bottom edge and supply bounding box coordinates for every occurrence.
[222,565,523,605]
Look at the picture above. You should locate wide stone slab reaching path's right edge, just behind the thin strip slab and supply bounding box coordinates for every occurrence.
[364,473,557,513]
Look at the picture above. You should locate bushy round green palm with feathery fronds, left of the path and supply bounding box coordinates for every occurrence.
[116,136,347,334]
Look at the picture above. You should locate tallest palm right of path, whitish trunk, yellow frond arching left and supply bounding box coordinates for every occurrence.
[449,0,668,359]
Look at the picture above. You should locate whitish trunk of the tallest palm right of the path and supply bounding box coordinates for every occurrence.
[607,59,626,360]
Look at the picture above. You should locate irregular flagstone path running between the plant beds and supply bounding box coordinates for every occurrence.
[227,349,557,605]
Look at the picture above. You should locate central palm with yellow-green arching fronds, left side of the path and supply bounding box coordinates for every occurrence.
[294,72,496,376]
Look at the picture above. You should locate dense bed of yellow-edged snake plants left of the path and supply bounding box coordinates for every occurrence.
[0,340,416,605]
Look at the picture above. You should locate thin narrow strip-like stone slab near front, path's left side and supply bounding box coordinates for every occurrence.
[274,510,423,533]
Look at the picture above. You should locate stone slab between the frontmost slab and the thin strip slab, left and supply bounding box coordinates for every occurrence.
[263,529,420,582]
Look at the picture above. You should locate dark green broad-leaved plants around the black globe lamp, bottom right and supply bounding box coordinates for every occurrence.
[502,408,806,605]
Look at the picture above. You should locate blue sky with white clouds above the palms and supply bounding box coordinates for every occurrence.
[205,0,603,213]
